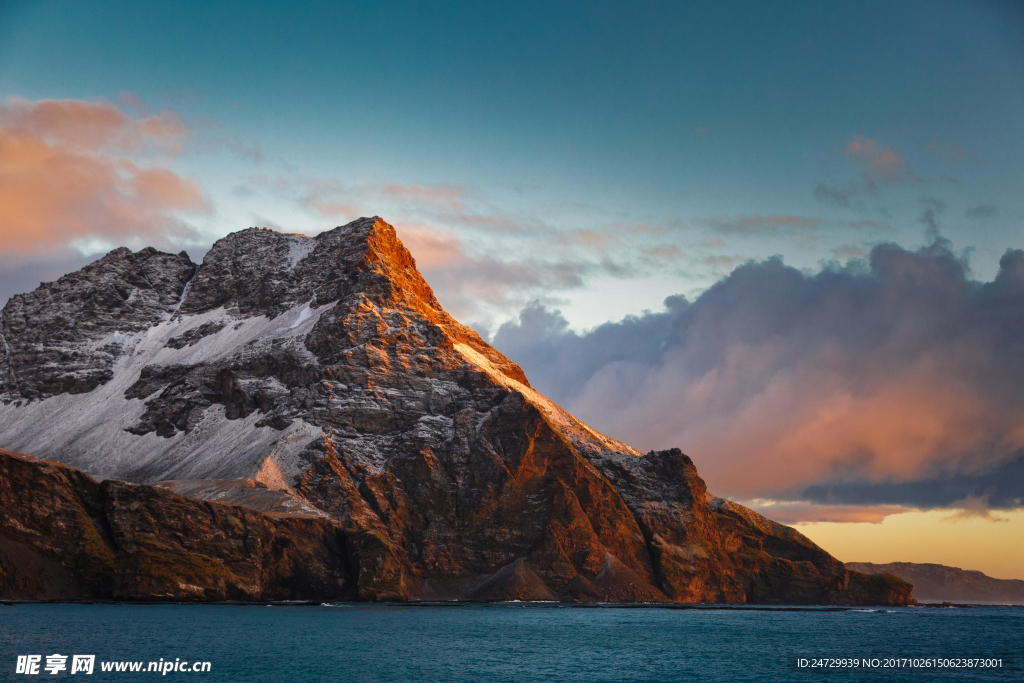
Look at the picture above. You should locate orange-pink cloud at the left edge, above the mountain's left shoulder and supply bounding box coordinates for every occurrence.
[0,98,209,254]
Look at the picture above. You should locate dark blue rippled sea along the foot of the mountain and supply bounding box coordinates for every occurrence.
[0,603,1024,682]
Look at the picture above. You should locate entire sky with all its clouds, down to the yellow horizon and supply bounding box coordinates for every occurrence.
[0,0,1024,579]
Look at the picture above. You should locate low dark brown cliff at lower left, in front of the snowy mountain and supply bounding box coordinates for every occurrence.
[0,451,405,600]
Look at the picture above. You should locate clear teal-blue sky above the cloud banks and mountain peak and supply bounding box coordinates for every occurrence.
[0,0,1024,328]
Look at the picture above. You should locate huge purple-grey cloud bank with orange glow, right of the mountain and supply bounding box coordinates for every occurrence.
[494,242,1024,506]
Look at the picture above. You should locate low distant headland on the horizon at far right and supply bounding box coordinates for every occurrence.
[846,562,1024,604]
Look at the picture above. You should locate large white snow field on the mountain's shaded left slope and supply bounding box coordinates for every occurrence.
[0,303,332,482]
